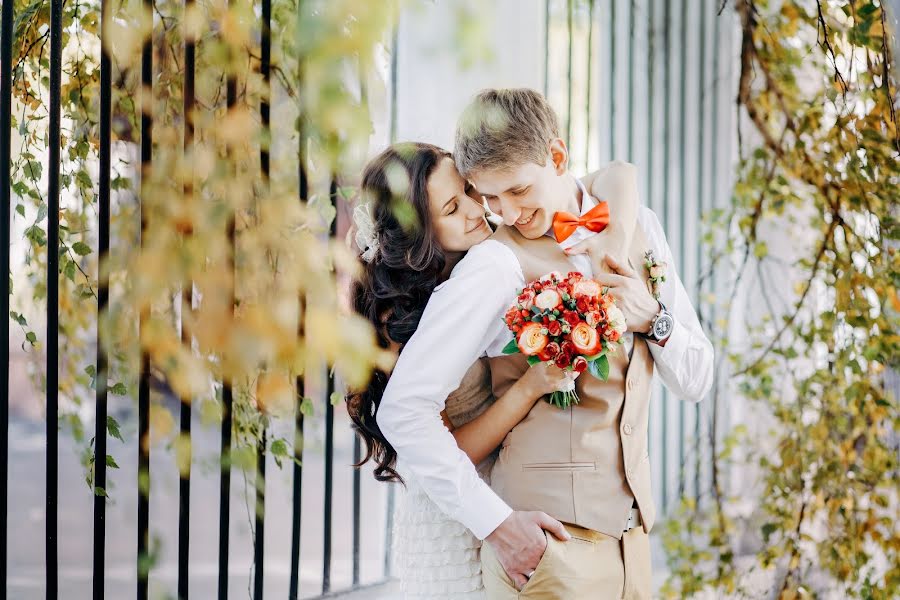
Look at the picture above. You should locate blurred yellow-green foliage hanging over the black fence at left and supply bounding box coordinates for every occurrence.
[11,0,398,480]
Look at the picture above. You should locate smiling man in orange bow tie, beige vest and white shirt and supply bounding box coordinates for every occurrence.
[377,89,713,600]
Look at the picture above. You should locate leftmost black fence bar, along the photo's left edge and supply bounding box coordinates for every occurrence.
[0,0,14,581]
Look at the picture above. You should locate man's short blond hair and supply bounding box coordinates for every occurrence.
[453,88,559,177]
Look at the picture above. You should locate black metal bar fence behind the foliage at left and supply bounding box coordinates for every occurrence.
[0,0,389,600]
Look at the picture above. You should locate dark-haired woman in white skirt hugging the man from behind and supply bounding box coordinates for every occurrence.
[347,143,600,600]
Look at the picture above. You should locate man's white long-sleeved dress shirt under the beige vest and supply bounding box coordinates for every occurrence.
[376,172,713,539]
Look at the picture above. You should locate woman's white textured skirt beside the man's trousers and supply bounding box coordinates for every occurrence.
[394,477,485,600]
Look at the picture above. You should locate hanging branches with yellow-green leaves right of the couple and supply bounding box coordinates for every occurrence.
[665,0,900,598]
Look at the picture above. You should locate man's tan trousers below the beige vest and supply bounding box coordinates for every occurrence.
[481,524,651,600]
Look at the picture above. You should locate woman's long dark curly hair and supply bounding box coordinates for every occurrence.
[347,142,450,483]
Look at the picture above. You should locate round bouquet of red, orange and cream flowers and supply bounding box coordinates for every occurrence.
[503,271,626,408]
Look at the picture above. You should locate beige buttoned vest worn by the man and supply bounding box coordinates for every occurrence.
[490,168,656,538]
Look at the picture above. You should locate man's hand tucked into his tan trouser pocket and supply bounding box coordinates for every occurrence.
[485,510,571,589]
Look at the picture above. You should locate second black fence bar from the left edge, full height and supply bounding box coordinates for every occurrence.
[46,0,63,599]
